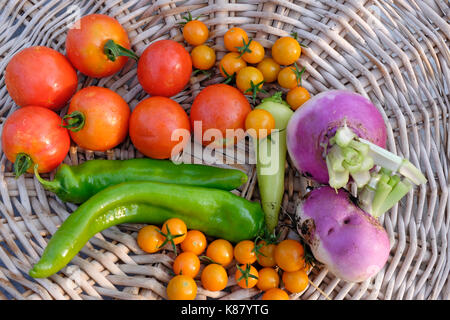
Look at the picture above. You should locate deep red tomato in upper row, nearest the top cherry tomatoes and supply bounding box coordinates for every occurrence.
[137,40,192,97]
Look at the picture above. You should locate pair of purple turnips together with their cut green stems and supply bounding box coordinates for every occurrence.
[287,90,427,282]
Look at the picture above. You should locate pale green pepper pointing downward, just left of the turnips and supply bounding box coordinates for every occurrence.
[253,92,294,232]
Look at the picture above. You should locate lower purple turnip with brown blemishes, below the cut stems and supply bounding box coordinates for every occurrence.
[296,186,390,282]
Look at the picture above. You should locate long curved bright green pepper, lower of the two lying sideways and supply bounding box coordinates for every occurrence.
[29,181,265,278]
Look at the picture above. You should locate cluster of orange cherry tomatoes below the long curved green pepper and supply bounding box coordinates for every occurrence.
[137,218,310,300]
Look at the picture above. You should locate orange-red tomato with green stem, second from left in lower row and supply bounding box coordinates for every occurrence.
[66,87,130,151]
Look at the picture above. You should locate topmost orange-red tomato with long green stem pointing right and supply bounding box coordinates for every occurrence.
[66,14,137,78]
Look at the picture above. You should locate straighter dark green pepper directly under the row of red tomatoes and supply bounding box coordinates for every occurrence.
[34,158,248,203]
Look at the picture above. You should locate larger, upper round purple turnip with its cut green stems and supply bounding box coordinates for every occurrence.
[286,90,427,217]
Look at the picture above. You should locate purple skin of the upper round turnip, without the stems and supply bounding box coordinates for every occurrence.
[287,90,387,184]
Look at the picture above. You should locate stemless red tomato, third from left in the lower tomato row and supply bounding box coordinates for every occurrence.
[129,97,190,159]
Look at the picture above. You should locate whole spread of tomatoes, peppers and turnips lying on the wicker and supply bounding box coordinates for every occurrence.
[2,6,426,299]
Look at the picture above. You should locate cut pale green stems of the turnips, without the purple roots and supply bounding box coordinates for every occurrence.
[326,125,427,217]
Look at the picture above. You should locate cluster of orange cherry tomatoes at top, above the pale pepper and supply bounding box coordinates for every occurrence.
[183,13,310,111]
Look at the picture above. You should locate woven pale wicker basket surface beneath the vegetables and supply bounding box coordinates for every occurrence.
[0,0,450,300]
